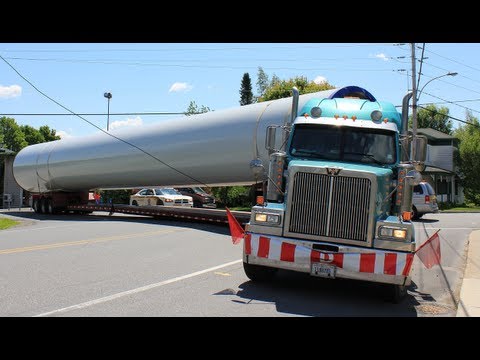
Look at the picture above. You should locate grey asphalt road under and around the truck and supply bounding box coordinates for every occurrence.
[0,210,480,317]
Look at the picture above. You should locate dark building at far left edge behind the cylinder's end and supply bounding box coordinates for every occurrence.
[0,144,23,209]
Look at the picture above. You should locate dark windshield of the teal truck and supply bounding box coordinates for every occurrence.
[290,124,397,165]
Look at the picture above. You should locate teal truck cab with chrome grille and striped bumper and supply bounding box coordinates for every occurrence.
[243,86,426,301]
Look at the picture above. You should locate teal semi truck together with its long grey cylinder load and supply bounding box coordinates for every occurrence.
[13,86,426,301]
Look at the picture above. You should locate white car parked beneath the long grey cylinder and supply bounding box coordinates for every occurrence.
[130,188,193,207]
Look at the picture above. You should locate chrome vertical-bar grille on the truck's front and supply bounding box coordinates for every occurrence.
[288,172,371,241]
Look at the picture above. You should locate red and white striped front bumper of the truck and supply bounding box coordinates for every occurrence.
[243,233,414,285]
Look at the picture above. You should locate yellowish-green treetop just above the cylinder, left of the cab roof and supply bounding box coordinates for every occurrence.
[258,74,334,102]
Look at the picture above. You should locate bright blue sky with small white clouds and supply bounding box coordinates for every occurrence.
[0,43,480,138]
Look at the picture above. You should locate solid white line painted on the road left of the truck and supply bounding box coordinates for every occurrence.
[33,259,243,317]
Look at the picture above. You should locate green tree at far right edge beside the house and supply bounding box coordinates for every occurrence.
[454,111,480,205]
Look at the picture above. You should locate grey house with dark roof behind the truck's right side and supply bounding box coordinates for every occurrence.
[417,128,464,204]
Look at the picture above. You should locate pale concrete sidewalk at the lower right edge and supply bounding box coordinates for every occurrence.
[457,230,480,317]
